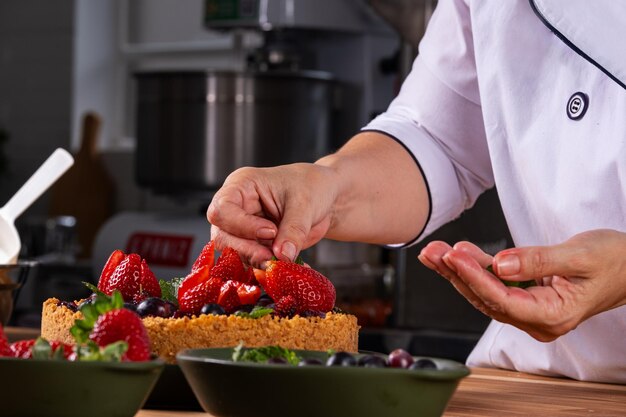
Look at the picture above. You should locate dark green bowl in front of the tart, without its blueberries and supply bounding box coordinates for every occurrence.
[177,348,469,417]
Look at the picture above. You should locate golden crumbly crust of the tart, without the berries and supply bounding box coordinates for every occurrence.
[41,298,359,363]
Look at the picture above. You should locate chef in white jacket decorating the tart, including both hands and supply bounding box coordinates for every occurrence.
[207,0,626,382]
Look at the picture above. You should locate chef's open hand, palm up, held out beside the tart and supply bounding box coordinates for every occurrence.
[418,230,626,342]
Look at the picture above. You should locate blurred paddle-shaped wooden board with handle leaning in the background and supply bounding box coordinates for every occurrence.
[49,113,115,258]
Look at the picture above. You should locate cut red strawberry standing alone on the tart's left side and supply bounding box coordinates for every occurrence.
[98,250,161,301]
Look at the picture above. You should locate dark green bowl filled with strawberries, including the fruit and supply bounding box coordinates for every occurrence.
[0,293,164,417]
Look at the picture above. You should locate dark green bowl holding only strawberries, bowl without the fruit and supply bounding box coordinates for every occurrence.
[0,358,164,417]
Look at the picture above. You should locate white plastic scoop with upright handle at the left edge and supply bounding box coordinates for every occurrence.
[0,148,74,265]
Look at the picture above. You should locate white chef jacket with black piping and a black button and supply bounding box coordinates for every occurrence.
[364,0,626,382]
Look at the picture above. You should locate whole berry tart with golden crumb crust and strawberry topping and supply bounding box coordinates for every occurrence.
[41,242,359,363]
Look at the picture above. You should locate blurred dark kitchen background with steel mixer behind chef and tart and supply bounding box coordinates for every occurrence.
[0,0,511,360]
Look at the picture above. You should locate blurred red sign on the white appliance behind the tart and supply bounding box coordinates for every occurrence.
[126,232,193,267]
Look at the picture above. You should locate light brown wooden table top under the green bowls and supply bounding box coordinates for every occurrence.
[136,368,626,417]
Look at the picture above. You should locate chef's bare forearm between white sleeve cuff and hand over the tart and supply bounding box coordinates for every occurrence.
[316,132,430,244]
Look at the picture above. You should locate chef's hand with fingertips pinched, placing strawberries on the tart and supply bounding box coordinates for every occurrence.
[207,163,338,267]
